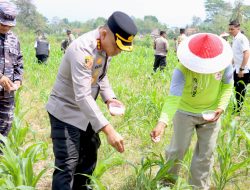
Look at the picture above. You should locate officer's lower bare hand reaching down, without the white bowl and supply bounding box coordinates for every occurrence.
[101,124,124,153]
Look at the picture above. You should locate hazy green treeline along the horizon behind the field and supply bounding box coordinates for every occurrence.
[12,0,250,38]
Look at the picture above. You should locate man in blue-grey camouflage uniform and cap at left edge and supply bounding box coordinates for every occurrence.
[0,1,23,136]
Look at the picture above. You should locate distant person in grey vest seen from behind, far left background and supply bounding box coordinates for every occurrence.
[34,34,50,63]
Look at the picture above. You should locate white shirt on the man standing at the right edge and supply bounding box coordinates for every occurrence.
[232,32,250,73]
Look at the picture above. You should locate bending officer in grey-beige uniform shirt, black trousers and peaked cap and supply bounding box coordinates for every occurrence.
[46,12,137,190]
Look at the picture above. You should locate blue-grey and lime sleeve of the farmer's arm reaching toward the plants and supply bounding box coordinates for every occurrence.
[159,69,185,124]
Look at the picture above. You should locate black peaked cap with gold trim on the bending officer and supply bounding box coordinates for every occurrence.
[108,11,137,51]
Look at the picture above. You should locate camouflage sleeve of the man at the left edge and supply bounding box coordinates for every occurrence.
[14,42,23,81]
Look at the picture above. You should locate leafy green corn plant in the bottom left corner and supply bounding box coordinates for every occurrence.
[0,136,48,189]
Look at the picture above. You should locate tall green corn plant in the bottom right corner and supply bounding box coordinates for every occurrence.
[213,120,250,190]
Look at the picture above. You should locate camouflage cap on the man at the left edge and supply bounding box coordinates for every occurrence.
[0,1,17,26]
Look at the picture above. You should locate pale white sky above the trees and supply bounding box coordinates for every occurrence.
[33,0,250,27]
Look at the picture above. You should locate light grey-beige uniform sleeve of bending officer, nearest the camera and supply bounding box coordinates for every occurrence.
[67,48,109,132]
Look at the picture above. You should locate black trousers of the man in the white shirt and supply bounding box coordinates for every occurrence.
[234,72,250,112]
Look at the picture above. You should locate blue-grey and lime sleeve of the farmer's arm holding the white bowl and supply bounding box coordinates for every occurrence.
[218,65,233,110]
